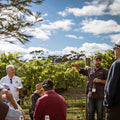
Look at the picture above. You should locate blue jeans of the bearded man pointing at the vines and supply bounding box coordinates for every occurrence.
[87,97,103,120]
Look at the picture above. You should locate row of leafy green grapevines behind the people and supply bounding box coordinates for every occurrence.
[0,50,115,96]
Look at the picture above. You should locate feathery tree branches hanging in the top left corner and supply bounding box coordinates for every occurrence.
[0,0,43,44]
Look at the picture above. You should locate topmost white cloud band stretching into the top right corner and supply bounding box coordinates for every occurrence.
[58,0,120,17]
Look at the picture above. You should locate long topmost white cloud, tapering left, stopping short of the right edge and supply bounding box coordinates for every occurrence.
[58,0,109,17]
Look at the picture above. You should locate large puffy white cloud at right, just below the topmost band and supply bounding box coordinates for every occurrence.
[81,20,120,34]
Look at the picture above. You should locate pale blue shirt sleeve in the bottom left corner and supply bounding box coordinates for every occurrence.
[5,107,22,120]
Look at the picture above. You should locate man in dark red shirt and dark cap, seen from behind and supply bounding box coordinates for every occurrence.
[33,79,67,120]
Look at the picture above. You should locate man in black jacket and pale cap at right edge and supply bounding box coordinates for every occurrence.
[104,41,120,120]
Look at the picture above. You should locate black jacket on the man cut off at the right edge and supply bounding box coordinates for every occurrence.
[104,59,120,108]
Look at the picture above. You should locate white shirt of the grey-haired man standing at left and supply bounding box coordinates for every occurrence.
[0,75,23,101]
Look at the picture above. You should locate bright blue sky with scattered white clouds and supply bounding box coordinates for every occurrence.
[0,0,120,58]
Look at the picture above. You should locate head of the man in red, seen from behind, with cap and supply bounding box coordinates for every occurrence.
[42,79,54,91]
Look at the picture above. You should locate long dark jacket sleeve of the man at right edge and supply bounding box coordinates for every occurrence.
[104,62,120,108]
